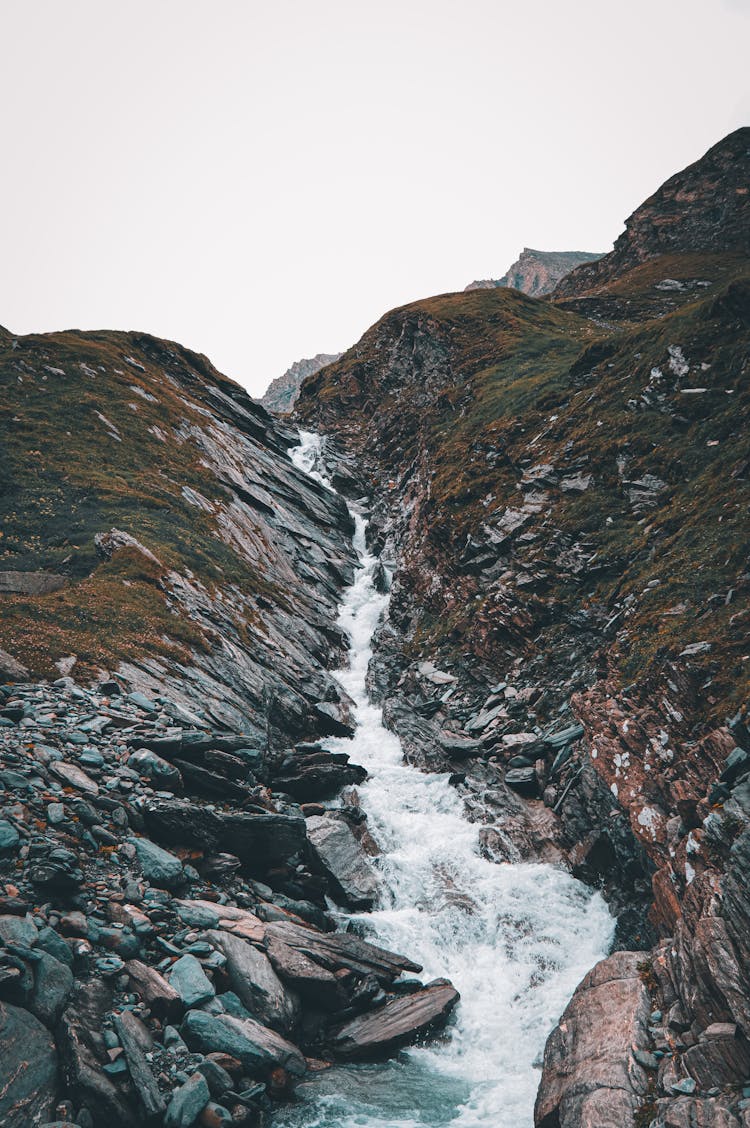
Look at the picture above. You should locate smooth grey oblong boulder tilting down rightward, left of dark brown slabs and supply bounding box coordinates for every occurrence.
[209,932,299,1033]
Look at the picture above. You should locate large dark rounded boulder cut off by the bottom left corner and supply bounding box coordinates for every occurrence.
[0,1002,58,1128]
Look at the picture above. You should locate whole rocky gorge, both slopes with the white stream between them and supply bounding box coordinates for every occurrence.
[0,129,750,1128]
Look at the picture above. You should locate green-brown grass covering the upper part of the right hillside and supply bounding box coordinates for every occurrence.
[299,256,750,714]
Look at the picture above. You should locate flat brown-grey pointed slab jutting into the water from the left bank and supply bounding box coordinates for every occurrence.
[333,979,460,1061]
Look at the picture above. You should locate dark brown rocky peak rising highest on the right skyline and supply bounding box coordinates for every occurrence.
[554,126,750,299]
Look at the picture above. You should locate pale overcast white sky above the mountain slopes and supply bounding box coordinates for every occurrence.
[0,0,750,395]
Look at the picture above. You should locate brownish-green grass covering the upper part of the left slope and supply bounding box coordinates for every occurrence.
[0,333,277,676]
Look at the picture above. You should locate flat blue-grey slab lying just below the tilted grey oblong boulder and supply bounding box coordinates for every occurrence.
[182,1011,307,1079]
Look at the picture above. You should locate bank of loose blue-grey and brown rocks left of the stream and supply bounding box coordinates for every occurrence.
[0,678,458,1128]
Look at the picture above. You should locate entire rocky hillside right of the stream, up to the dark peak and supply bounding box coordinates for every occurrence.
[297,130,750,1128]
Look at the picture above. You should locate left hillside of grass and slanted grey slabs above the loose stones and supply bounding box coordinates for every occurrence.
[0,333,354,747]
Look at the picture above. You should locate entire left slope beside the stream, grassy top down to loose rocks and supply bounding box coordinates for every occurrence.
[0,331,458,1128]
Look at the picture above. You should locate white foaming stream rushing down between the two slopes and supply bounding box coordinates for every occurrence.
[276,432,614,1128]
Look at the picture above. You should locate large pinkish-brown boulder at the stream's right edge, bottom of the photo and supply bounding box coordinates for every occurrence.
[535,952,648,1128]
